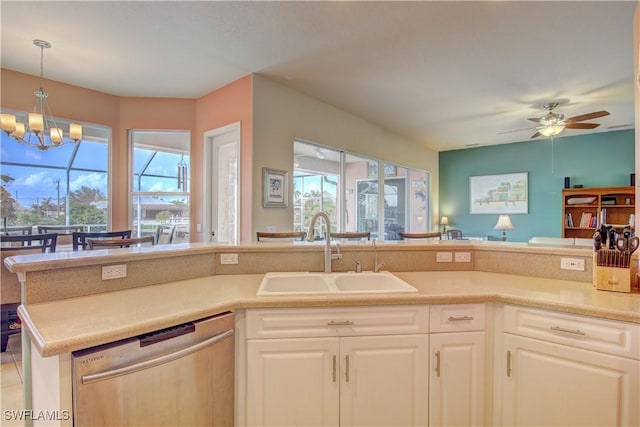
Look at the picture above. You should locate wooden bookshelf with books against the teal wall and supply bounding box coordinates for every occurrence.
[562,187,636,238]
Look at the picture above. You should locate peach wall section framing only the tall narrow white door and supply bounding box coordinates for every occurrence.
[191,75,253,241]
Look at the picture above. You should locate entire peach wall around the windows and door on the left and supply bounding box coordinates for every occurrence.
[0,69,252,241]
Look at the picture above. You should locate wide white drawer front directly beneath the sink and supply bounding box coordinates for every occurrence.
[246,305,429,339]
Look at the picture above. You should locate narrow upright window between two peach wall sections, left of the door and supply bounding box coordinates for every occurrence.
[130,130,191,243]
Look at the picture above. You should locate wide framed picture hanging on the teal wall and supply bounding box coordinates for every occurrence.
[469,172,529,214]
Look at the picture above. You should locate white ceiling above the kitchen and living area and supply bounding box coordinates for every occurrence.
[0,0,637,151]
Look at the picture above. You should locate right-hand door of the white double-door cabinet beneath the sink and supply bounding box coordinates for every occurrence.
[340,335,429,426]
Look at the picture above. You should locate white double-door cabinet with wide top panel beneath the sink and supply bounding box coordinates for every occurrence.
[246,306,429,426]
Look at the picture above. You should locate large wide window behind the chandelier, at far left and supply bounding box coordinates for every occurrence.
[0,111,111,231]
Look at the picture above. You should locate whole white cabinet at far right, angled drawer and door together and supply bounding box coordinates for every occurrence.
[500,306,640,426]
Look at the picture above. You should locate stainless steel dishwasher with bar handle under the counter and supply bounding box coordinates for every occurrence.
[72,313,234,427]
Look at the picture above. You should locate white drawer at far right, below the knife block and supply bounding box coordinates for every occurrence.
[504,305,640,360]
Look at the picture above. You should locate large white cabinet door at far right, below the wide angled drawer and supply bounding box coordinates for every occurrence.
[502,334,640,426]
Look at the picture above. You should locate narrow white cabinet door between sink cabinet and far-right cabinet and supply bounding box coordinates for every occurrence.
[429,332,485,426]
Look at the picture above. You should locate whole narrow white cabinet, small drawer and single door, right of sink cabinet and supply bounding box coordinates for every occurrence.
[429,304,485,426]
